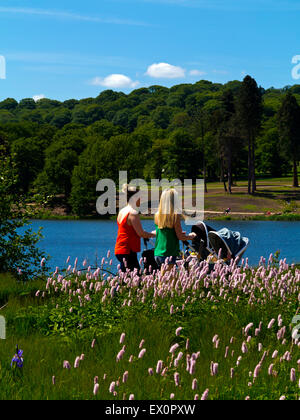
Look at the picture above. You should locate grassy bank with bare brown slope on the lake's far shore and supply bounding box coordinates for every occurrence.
[29,178,300,221]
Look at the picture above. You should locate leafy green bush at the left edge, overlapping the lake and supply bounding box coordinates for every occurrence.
[0,147,44,280]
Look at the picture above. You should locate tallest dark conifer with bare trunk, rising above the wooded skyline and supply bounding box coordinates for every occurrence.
[236,76,262,194]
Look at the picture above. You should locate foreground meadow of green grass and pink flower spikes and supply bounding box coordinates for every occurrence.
[0,253,300,400]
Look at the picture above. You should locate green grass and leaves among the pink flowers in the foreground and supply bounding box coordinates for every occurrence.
[0,266,300,400]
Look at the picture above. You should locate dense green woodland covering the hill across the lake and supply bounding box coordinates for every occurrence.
[0,76,300,216]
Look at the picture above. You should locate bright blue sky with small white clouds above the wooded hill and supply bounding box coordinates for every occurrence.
[0,0,300,100]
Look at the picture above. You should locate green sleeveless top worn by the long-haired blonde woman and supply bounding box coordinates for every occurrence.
[154,225,180,257]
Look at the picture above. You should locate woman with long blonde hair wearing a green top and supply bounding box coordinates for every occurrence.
[154,188,196,269]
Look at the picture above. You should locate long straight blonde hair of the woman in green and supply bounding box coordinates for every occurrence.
[154,188,179,229]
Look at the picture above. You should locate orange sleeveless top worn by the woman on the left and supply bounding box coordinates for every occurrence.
[115,212,141,255]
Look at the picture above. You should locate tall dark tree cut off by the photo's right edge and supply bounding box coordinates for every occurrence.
[278,92,300,187]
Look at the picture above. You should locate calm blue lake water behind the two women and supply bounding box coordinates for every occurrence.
[25,220,300,268]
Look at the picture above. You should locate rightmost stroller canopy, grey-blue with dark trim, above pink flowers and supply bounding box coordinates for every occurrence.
[208,228,249,258]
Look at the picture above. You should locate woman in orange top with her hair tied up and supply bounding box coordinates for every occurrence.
[115,184,155,272]
